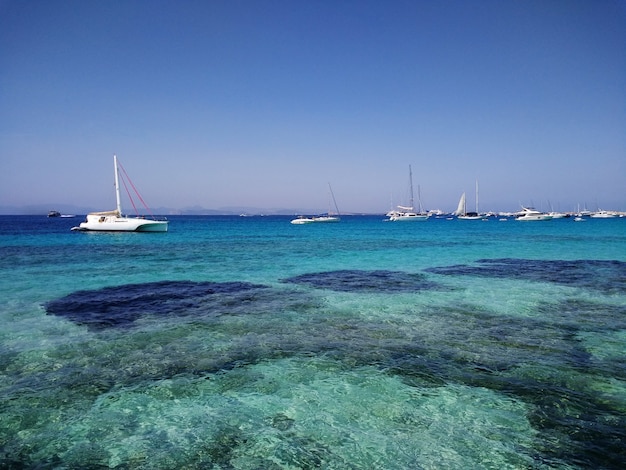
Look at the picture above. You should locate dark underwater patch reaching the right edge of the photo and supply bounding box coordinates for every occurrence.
[426,258,626,292]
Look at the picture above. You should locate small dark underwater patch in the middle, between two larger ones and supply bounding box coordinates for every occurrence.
[282,269,440,293]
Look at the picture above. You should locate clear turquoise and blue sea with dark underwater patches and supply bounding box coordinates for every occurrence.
[0,215,626,470]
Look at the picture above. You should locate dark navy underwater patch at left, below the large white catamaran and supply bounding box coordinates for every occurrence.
[45,281,267,329]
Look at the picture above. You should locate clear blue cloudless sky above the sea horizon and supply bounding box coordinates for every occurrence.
[0,0,626,212]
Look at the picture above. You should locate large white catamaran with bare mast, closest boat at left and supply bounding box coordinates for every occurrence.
[72,155,168,232]
